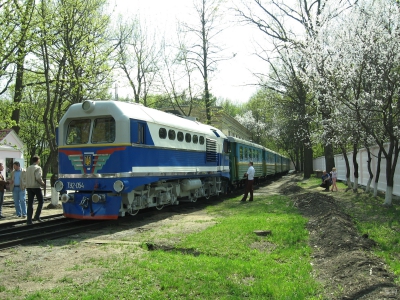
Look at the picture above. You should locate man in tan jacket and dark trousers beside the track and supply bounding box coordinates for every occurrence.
[26,155,46,225]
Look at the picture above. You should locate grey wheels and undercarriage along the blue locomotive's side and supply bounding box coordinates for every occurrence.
[119,177,227,216]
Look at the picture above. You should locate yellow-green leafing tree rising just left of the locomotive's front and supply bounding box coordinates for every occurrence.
[32,0,114,188]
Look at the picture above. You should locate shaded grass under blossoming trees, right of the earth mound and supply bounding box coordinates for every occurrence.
[299,177,400,284]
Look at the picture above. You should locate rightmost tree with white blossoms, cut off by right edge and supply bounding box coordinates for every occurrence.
[309,1,400,205]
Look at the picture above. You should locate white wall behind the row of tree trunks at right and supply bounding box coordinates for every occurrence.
[313,146,400,196]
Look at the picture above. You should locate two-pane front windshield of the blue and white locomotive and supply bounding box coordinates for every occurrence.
[66,117,115,145]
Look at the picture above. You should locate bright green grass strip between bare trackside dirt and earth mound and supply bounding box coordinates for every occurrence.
[21,192,322,299]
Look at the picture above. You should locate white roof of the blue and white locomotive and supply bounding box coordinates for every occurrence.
[64,100,225,138]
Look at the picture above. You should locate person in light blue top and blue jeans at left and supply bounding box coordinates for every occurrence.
[10,161,26,218]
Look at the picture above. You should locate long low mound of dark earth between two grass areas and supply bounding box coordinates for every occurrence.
[281,177,400,300]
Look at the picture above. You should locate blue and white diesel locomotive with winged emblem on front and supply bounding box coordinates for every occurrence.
[54,101,230,219]
